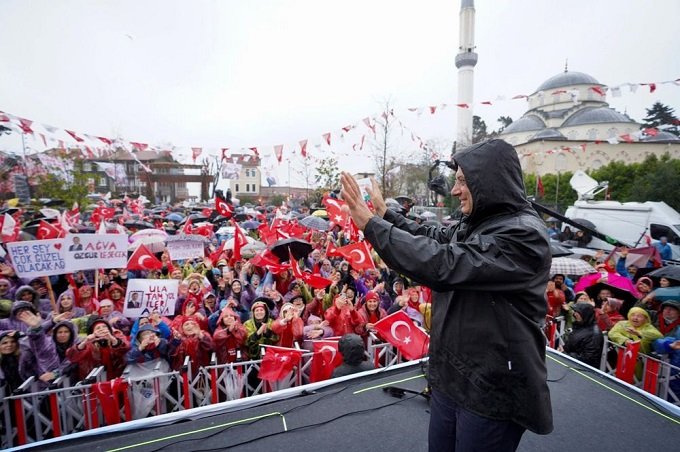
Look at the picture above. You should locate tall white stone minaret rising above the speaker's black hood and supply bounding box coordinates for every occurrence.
[456,0,477,149]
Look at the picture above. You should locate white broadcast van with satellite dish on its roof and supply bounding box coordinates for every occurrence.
[565,171,680,259]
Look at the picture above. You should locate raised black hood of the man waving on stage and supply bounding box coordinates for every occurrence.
[453,140,529,224]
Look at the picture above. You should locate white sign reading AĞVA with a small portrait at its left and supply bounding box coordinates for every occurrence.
[64,234,128,273]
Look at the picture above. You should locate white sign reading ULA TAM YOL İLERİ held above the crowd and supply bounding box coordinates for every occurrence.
[123,279,179,318]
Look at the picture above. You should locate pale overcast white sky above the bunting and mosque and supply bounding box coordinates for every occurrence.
[0,0,680,194]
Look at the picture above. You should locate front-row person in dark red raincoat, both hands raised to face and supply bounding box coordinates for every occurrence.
[66,316,130,381]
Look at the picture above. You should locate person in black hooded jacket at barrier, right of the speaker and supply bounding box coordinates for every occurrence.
[564,303,604,369]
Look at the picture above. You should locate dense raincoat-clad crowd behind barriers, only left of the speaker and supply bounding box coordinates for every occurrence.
[0,202,430,400]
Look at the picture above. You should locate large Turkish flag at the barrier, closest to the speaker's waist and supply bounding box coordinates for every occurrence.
[375,310,430,360]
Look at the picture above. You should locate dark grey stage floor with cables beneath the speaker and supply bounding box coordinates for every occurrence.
[21,353,680,452]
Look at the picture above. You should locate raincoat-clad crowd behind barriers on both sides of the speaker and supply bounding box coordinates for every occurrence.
[0,194,680,430]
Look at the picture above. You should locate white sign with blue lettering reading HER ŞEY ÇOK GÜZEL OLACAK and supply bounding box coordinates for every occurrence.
[7,239,68,278]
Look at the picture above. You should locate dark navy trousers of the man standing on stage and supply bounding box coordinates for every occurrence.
[428,390,525,452]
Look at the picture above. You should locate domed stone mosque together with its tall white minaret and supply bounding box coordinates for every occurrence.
[456,0,680,175]
